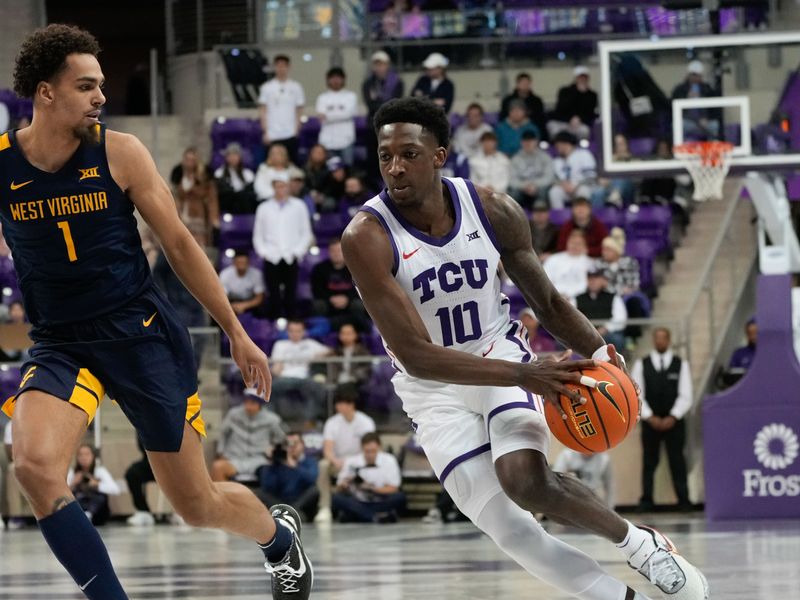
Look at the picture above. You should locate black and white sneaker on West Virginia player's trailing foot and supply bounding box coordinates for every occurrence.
[264,504,314,600]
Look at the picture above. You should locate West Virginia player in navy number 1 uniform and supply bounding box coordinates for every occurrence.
[0,25,313,600]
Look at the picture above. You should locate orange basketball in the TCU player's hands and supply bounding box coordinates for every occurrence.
[544,362,639,454]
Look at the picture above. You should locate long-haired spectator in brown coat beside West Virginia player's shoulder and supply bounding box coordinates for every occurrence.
[173,148,219,246]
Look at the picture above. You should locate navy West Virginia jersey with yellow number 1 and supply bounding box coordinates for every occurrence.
[0,125,151,326]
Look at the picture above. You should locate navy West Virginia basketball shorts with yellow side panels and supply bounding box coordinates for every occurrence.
[3,286,205,452]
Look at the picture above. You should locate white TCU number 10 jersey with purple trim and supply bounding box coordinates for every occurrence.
[361,177,509,371]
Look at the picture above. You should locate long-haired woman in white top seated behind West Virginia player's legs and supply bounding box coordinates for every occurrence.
[67,444,121,525]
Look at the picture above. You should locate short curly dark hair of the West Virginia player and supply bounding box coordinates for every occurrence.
[14,23,100,98]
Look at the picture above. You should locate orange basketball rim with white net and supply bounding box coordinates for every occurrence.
[673,142,733,201]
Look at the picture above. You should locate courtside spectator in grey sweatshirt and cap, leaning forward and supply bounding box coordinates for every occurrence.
[211,388,286,481]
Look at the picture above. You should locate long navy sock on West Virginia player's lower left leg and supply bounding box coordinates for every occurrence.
[39,502,128,600]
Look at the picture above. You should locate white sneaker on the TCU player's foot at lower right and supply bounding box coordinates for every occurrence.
[628,525,708,600]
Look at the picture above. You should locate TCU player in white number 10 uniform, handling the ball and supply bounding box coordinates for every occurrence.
[342,98,708,600]
